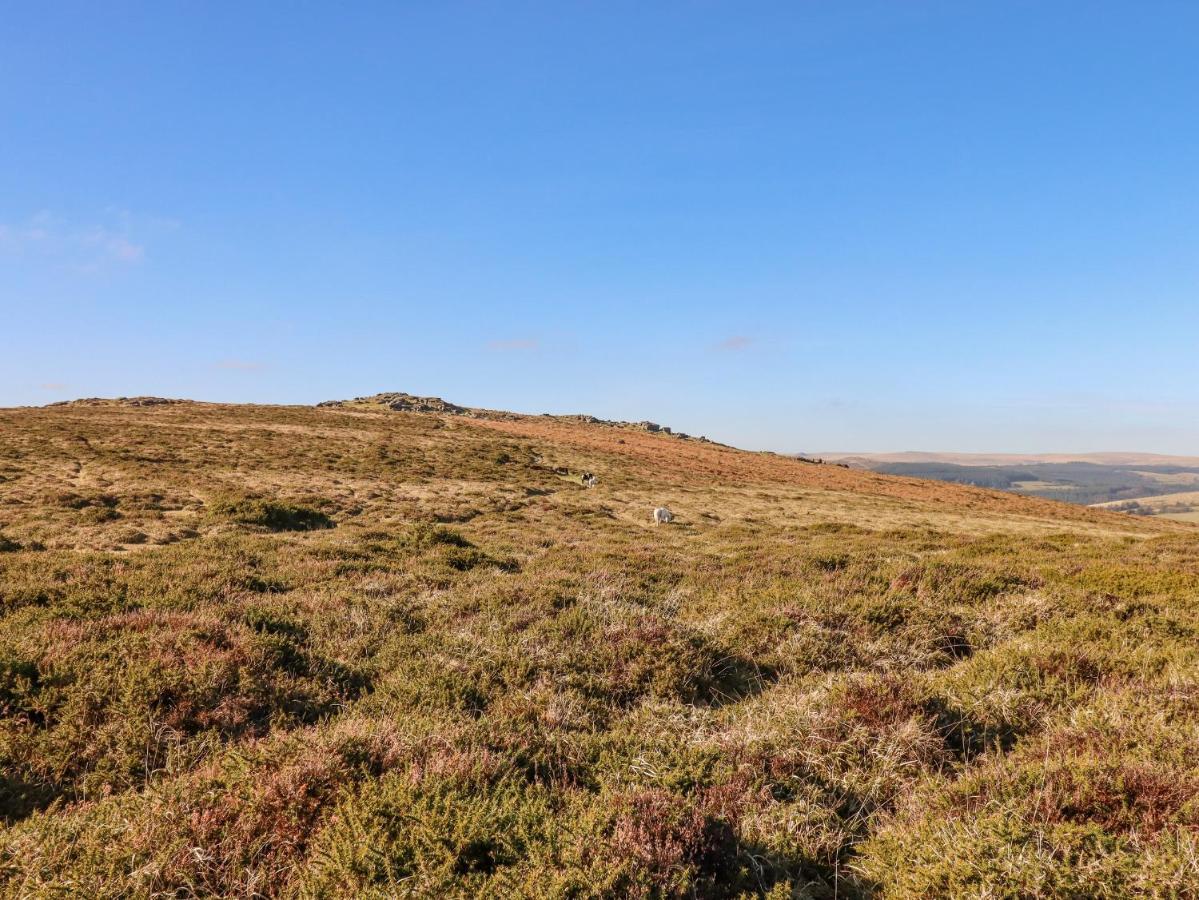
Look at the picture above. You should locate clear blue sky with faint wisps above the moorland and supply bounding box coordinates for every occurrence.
[0,0,1199,454]
